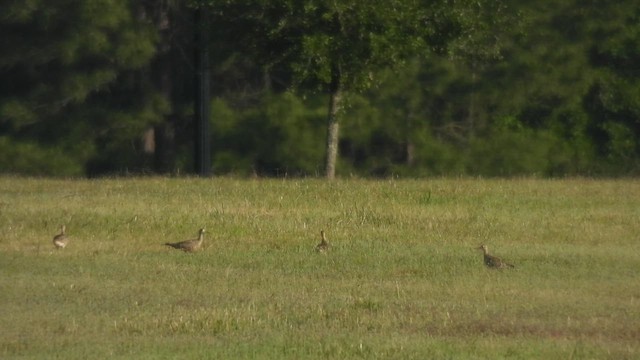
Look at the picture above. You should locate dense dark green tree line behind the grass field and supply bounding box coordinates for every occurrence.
[0,0,640,177]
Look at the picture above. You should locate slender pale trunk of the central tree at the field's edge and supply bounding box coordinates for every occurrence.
[325,67,342,180]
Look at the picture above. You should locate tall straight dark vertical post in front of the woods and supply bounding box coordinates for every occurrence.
[194,8,211,176]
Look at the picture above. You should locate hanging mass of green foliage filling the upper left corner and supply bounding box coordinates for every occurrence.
[0,0,155,122]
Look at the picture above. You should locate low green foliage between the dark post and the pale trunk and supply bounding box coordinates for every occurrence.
[211,92,324,176]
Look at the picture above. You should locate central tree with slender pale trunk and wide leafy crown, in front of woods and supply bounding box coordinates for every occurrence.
[201,0,458,179]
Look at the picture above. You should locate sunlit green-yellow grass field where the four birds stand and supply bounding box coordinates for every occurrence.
[0,177,640,359]
